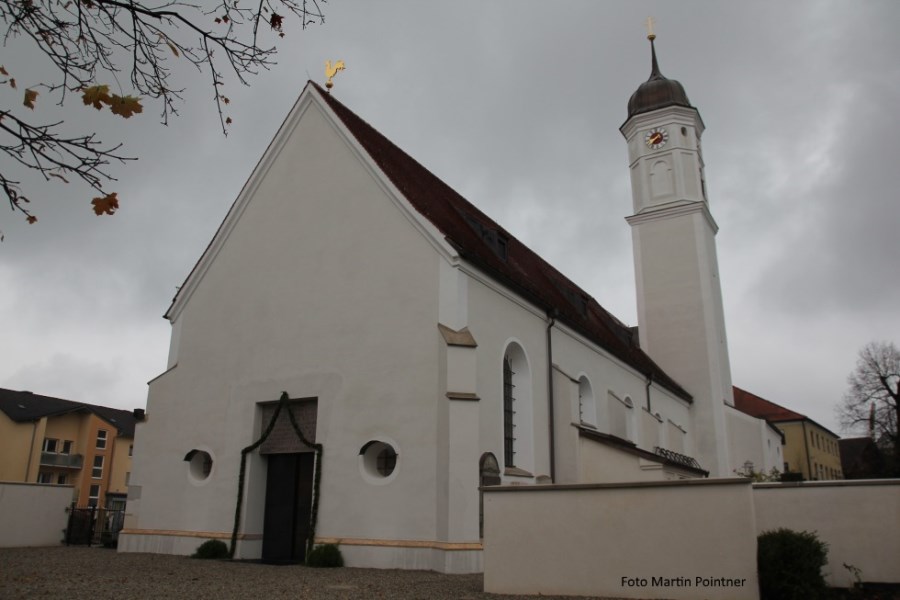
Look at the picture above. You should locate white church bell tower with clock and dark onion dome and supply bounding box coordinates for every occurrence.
[620,31,734,477]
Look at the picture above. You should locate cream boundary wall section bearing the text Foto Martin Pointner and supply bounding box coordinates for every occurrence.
[484,478,759,600]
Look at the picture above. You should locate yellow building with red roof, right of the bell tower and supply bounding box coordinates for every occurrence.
[734,386,844,481]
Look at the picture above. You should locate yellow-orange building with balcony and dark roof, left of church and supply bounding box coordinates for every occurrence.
[0,388,137,508]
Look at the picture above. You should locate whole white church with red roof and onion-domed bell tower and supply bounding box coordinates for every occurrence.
[119,37,781,572]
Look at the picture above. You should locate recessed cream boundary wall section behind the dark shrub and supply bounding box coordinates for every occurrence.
[753,479,900,587]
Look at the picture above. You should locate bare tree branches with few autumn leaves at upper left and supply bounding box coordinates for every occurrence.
[0,0,325,227]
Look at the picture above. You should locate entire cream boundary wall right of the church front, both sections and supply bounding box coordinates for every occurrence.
[484,479,900,600]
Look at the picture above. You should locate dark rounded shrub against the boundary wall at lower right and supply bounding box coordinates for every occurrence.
[756,529,828,600]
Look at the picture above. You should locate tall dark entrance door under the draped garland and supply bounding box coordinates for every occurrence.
[262,452,315,564]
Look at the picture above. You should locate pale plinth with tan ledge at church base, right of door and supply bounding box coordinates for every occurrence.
[316,537,482,574]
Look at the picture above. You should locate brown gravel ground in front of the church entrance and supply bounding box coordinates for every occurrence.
[0,546,628,600]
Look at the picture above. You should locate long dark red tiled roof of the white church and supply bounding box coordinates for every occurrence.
[308,82,692,402]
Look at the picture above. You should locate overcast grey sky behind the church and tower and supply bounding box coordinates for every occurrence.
[0,0,900,433]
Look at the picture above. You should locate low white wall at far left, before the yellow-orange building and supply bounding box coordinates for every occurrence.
[0,481,72,548]
